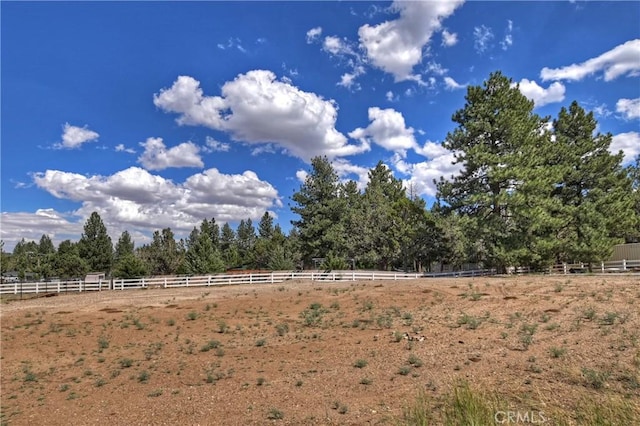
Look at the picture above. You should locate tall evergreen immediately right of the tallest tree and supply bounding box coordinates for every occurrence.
[553,101,636,263]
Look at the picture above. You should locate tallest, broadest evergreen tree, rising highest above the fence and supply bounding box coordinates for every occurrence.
[437,72,557,272]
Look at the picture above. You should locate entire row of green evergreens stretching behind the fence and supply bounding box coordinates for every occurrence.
[2,72,640,278]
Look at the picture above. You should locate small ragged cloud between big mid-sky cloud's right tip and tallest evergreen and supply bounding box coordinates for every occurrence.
[392,142,462,197]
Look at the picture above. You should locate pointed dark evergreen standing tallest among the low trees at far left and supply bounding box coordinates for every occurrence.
[78,212,113,274]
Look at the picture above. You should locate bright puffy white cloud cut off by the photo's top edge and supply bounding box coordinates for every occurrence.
[358,0,463,81]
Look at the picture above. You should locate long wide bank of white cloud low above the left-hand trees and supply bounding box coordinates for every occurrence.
[25,167,282,245]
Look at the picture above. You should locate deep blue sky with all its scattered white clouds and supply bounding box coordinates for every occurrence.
[0,1,640,250]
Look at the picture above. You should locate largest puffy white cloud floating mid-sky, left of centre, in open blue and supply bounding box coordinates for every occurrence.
[154,70,369,161]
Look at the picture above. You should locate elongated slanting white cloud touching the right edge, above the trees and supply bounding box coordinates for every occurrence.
[540,39,640,81]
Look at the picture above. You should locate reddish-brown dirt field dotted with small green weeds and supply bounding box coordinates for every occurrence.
[0,276,640,425]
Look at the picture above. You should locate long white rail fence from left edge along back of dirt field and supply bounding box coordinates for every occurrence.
[0,269,495,295]
